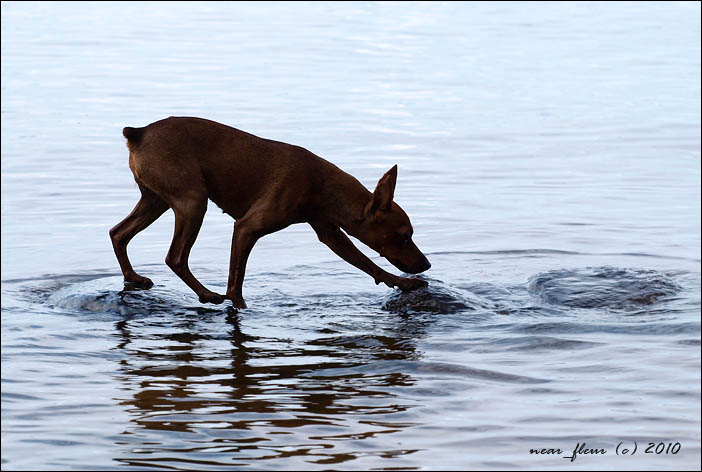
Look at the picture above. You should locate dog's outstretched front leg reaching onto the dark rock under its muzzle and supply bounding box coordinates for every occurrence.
[310,222,427,290]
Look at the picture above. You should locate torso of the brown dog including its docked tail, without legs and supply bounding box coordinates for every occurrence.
[123,117,324,219]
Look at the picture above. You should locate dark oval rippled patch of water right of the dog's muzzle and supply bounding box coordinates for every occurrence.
[528,266,680,308]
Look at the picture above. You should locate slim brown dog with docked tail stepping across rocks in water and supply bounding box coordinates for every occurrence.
[110,117,431,308]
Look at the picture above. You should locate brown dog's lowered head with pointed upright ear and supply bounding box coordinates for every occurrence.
[356,165,431,274]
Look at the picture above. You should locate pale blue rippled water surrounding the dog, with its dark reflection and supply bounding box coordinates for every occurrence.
[2,2,700,470]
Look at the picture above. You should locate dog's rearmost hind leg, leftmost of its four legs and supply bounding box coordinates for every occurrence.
[110,184,168,288]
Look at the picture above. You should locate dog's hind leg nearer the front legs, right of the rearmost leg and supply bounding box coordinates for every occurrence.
[166,195,224,304]
